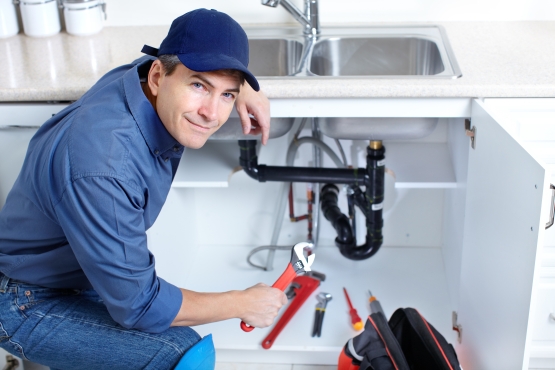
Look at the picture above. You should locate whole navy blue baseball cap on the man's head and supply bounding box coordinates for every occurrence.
[141,9,260,91]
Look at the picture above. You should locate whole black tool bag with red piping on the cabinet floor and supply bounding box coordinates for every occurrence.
[338,308,461,370]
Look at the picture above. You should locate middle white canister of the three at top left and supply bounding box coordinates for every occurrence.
[19,0,61,37]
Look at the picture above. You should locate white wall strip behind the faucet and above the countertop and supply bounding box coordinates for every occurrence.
[106,0,555,26]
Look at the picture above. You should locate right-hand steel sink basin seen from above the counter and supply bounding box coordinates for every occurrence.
[310,37,445,76]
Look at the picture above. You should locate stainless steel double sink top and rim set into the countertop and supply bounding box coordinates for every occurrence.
[246,25,462,79]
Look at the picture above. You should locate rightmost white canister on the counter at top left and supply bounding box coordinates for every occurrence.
[63,0,106,36]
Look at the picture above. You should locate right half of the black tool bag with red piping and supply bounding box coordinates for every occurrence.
[389,308,461,370]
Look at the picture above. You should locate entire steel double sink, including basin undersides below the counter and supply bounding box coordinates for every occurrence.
[215,25,462,140]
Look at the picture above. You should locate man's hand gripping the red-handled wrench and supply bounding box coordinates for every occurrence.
[236,283,287,328]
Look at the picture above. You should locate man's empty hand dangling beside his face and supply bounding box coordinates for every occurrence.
[235,82,270,145]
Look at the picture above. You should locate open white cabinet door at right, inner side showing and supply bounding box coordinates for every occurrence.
[457,100,547,370]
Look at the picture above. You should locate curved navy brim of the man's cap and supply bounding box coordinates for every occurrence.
[177,53,260,91]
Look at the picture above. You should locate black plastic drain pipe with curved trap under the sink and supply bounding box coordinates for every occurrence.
[239,140,385,260]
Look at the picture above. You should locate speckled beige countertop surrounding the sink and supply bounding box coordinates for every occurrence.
[0,21,555,102]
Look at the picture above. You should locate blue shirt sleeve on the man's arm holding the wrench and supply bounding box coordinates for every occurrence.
[55,176,182,333]
